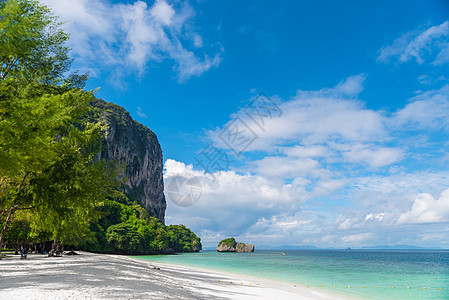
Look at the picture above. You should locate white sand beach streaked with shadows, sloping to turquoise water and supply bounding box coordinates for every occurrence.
[0,252,347,300]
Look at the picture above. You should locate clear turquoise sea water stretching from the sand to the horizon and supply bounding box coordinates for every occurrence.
[137,250,449,299]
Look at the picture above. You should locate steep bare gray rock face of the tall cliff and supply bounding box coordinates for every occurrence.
[93,100,167,223]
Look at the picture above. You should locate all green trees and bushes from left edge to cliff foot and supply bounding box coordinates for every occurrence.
[0,0,201,253]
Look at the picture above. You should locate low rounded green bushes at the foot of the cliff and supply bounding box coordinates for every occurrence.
[81,191,201,254]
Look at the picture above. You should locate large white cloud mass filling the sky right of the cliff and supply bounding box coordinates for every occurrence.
[169,74,449,247]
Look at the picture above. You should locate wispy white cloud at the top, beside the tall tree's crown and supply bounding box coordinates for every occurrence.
[41,0,223,81]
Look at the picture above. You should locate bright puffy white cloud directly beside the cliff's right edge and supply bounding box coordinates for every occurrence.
[164,159,294,232]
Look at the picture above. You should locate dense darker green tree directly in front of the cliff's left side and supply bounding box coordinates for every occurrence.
[30,124,118,245]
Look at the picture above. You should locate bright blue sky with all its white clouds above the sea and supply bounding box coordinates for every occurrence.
[42,0,449,248]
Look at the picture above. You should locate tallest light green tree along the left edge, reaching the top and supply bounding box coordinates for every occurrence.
[0,0,74,251]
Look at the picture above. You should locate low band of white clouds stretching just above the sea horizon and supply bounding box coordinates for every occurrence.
[164,159,449,247]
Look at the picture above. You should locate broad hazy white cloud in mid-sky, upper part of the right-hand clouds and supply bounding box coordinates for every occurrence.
[209,75,386,151]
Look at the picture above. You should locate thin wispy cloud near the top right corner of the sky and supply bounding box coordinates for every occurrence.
[377,21,449,64]
